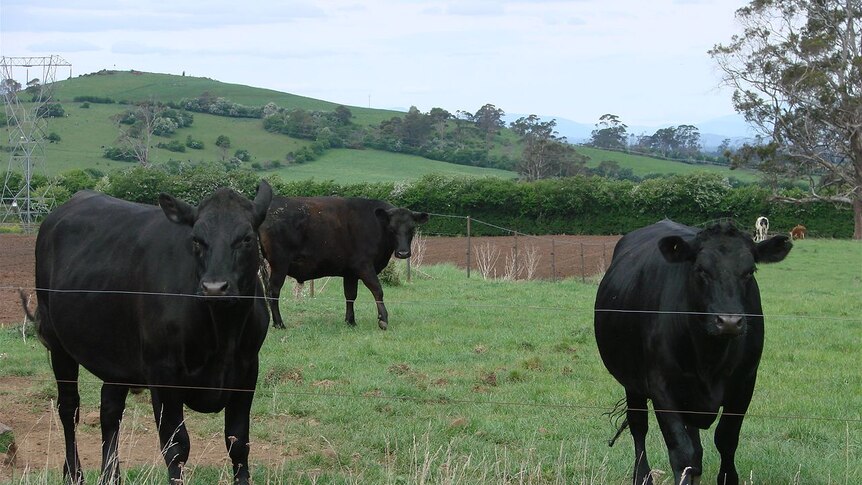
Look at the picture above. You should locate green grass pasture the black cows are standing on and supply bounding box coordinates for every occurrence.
[0,239,862,484]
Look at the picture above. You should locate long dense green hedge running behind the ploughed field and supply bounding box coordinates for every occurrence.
[20,163,853,238]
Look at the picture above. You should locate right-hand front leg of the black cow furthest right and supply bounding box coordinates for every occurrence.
[714,378,754,485]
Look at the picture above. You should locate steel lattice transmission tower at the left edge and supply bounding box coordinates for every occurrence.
[0,56,72,231]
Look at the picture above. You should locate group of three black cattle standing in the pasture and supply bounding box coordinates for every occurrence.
[31,181,792,485]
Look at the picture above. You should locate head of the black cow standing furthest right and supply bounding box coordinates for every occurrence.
[659,223,793,337]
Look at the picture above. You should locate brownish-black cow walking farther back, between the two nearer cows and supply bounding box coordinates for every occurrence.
[260,197,428,330]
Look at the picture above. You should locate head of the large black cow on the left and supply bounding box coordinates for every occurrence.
[159,180,272,297]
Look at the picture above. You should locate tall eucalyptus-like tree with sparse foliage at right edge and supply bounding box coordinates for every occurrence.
[709,0,862,240]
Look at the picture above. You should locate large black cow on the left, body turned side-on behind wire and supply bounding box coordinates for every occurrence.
[35,182,272,485]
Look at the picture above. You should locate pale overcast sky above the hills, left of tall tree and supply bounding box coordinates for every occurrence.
[0,0,748,126]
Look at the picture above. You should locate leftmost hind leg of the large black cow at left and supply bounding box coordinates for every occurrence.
[51,345,84,485]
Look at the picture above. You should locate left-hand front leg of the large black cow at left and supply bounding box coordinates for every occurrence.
[150,388,190,484]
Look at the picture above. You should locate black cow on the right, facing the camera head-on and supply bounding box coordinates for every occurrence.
[595,220,792,485]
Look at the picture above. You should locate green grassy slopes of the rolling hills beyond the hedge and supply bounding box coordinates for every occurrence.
[3,71,755,183]
